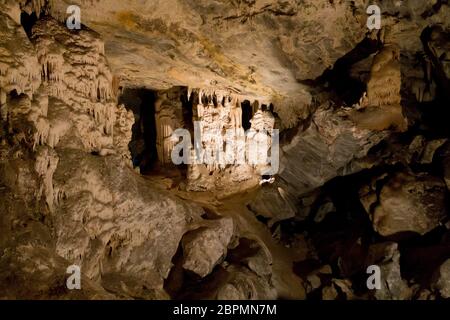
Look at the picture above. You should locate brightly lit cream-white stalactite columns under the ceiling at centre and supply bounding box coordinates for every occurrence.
[184,90,275,192]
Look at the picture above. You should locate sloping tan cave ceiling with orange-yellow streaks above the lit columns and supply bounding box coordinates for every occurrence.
[48,0,365,107]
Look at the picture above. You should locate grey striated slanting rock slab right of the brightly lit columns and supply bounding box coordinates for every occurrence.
[251,106,387,220]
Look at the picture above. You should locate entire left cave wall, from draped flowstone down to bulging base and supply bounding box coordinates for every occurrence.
[1,5,253,298]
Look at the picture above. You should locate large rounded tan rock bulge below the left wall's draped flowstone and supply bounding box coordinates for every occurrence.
[54,149,206,288]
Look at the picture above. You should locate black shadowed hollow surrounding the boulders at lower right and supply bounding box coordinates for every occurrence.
[284,162,450,300]
